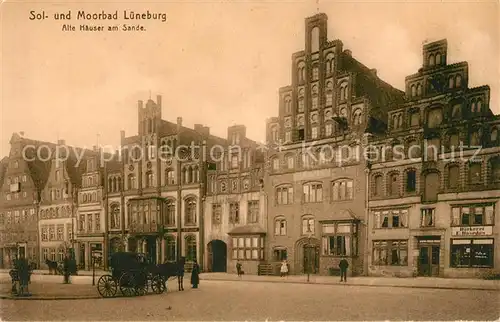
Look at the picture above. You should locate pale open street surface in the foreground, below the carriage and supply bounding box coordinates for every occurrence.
[1,279,500,321]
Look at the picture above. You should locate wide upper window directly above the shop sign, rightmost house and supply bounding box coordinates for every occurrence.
[451,204,495,226]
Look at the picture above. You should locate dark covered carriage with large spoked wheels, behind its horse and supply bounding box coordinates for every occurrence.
[97,252,168,297]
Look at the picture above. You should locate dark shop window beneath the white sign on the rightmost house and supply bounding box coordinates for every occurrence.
[450,239,494,268]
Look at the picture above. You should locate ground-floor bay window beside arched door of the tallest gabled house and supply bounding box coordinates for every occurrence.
[322,222,357,256]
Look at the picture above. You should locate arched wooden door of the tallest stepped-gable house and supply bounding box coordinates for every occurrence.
[295,238,320,274]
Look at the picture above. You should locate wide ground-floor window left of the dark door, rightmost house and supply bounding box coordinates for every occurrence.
[372,240,408,266]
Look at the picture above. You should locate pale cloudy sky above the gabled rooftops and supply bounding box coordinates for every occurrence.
[0,0,500,157]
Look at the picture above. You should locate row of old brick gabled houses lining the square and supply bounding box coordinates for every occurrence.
[0,14,500,277]
